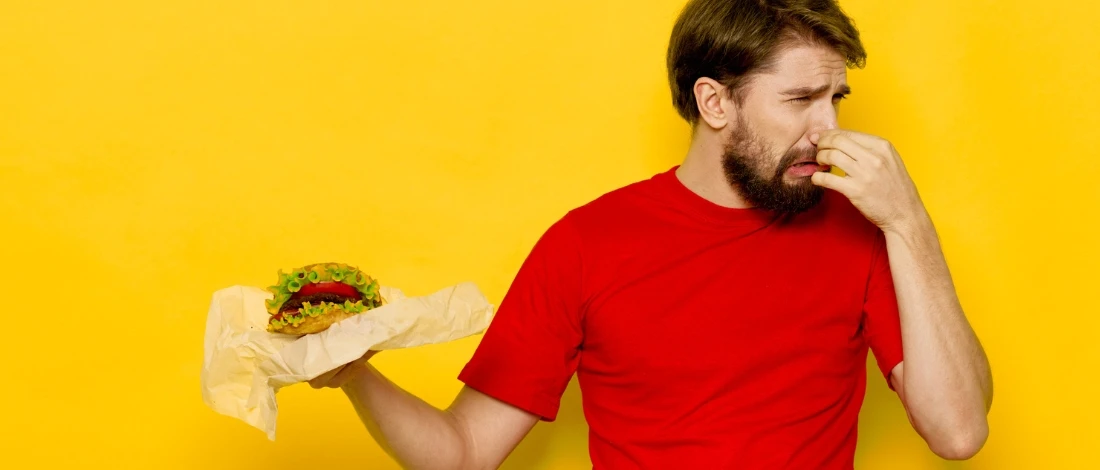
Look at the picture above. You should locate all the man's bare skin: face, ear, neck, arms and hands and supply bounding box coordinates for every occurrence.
[310,37,992,469]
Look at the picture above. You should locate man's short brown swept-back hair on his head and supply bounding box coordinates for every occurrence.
[667,0,867,124]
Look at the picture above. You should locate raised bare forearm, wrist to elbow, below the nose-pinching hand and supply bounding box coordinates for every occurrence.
[886,216,992,458]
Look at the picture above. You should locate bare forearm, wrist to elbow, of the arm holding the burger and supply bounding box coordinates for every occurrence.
[342,365,468,469]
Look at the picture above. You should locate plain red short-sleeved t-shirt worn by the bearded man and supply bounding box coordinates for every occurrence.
[459,168,902,470]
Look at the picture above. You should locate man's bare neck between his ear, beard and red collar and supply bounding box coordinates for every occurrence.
[677,134,749,209]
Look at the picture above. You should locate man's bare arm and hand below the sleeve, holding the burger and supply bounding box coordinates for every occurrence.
[310,354,538,470]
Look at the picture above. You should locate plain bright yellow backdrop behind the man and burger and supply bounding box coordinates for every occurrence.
[0,0,1100,470]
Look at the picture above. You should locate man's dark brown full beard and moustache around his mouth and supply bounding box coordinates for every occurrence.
[722,116,825,215]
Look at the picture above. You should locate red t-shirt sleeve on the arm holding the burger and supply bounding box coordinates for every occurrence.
[459,218,582,420]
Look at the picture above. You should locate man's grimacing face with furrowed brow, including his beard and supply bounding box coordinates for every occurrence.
[723,45,849,214]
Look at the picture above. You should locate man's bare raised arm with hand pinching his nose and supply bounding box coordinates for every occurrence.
[811,130,993,459]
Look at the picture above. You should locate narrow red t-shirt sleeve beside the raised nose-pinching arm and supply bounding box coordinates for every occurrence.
[864,231,903,389]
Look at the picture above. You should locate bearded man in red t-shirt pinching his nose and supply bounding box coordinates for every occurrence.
[312,0,992,469]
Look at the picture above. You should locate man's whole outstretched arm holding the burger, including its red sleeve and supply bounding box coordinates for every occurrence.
[311,218,584,470]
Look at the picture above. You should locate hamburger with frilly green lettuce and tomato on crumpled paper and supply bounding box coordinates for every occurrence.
[266,263,386,335]
